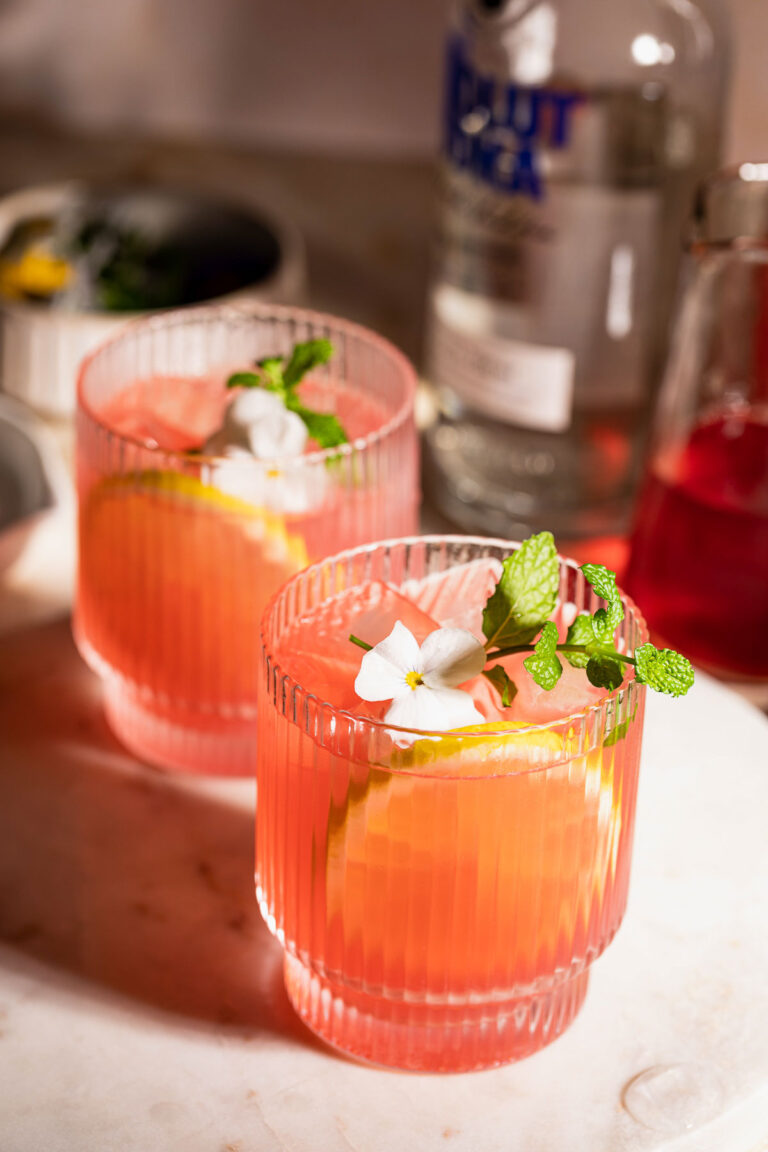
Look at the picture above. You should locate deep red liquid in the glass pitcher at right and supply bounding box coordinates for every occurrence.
[625,410,768,679]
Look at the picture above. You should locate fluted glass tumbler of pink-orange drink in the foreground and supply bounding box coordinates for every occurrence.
[256,537,646,1071]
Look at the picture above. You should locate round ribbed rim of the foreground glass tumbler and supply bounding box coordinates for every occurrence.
[259,532,648,746]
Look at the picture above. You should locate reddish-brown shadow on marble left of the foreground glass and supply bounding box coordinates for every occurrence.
[0,619,327,1051]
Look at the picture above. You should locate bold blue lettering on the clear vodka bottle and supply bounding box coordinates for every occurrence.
[444,37,586,200]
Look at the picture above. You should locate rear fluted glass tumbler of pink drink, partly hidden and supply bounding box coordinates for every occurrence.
[75,304,418,774]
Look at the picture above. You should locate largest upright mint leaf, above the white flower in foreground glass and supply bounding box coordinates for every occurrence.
[482,532,560,647]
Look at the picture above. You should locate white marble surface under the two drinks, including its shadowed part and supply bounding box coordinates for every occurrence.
[0,509,768,1152]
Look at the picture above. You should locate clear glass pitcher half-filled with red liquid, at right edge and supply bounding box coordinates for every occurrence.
[625,164,768,686]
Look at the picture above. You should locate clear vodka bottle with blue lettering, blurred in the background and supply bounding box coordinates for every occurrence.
[426,0,728,538]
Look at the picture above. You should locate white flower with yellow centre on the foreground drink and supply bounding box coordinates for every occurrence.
[355,620,486,732]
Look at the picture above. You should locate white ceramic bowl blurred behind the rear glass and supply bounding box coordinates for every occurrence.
[0,182,305,416]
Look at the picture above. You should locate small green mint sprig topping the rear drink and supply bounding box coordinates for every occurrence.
[227,340,349,448]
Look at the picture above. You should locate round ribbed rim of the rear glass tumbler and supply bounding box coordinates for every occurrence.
[76,301,418,472]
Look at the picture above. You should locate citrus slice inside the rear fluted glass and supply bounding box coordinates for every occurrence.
[78,470,307,707]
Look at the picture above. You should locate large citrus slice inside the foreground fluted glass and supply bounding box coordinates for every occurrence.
[325,721,621,987]
